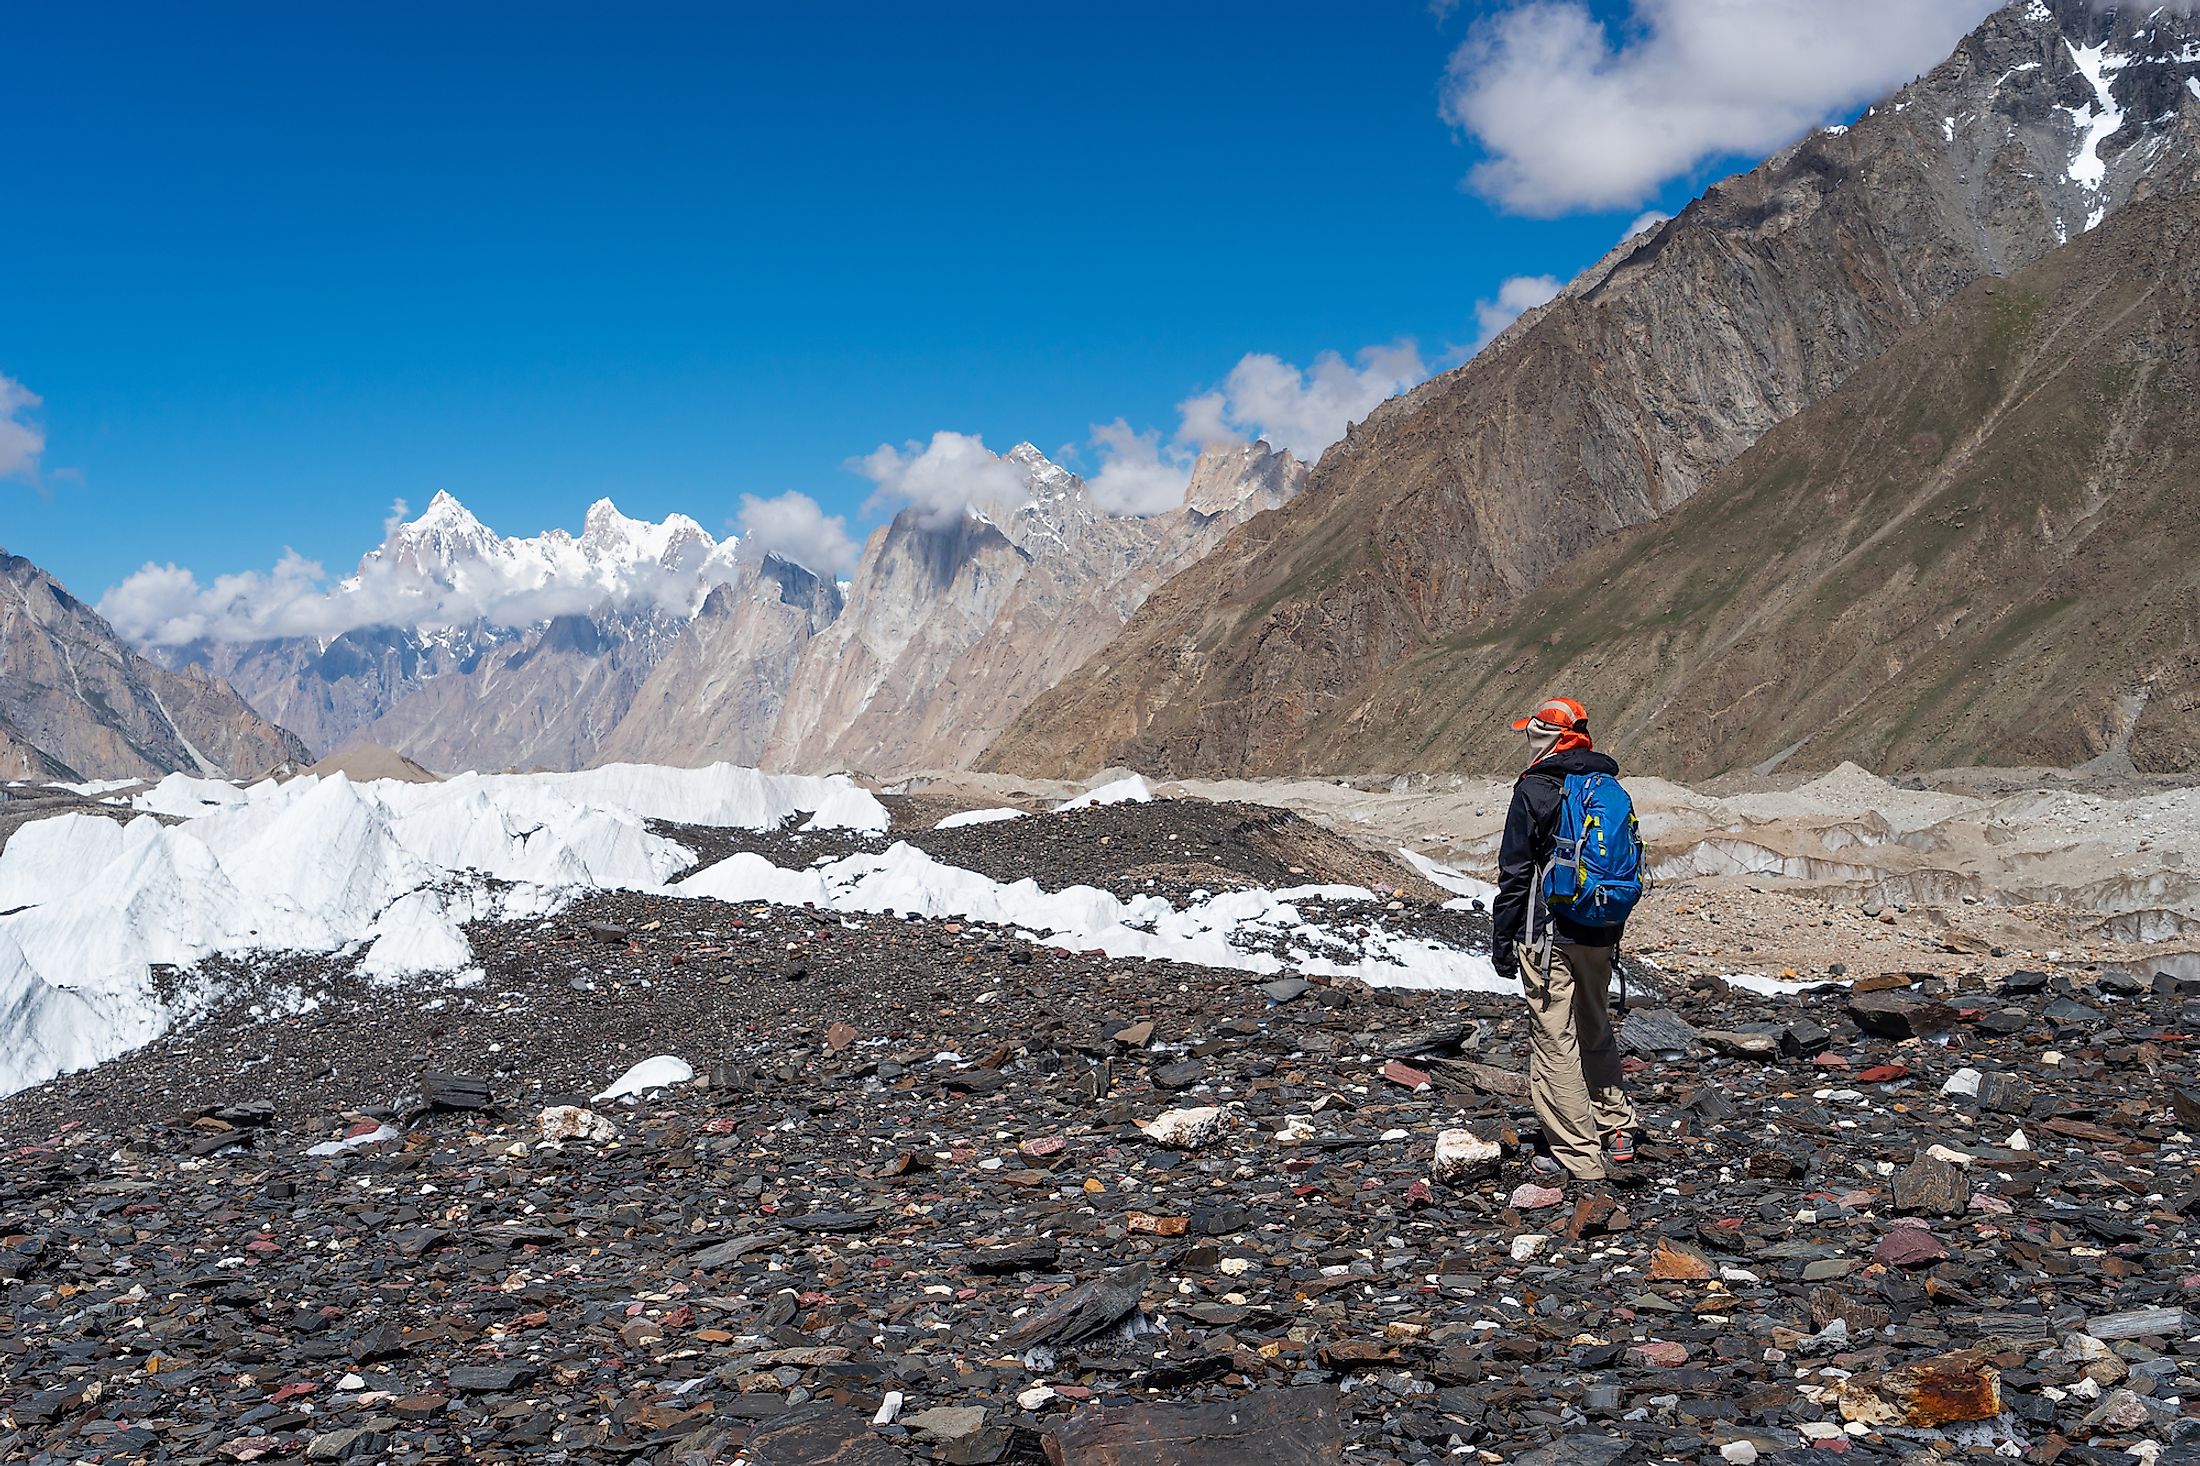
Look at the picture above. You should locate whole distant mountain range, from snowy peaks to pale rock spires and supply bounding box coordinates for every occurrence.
[156,433,1305,773]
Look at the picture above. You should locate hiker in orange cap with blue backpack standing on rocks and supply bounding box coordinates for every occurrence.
[1489,698,1641,1182]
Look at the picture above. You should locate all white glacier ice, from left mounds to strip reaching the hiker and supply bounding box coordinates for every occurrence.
[0,752,1507,1094]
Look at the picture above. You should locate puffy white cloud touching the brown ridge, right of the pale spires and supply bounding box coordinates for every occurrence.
[1177,341,1428,462]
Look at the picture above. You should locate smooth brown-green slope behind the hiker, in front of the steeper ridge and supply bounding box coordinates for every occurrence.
[1313,198,2200,779]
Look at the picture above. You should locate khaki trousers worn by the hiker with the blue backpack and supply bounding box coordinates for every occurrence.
[1514,942,1635,1180]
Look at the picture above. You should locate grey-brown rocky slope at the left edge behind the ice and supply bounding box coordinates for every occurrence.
[0,550,306,779]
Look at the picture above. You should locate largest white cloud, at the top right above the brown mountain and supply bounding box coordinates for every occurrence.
[1441,0,1998,216]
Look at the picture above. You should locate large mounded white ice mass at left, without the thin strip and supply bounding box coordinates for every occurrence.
[0,764,887,1094]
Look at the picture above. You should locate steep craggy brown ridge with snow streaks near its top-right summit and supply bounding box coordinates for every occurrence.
[983,0,2200,775]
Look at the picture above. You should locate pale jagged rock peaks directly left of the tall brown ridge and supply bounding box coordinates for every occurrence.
[766,442,1305,773]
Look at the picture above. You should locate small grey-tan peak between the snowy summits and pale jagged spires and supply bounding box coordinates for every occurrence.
[601,555,840,764]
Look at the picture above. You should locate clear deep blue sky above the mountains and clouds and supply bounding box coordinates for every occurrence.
[0,0,1997,611]
